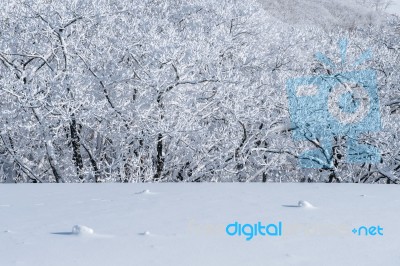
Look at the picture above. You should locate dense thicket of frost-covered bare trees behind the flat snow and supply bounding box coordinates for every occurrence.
[0,0,400,182]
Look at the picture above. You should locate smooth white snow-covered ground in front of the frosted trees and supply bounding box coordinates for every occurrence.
[0,184,400,266]
